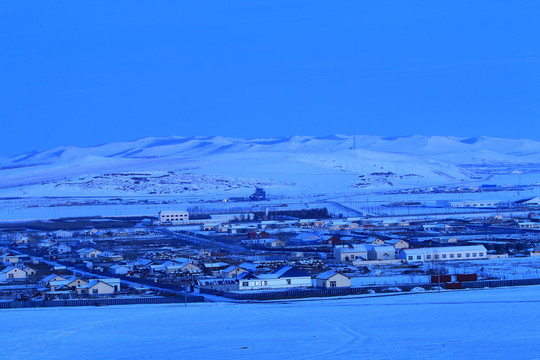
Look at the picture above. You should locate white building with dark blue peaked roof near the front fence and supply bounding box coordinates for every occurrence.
[237,265,312,290]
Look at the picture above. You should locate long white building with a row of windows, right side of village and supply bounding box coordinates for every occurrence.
[399,245,487,263]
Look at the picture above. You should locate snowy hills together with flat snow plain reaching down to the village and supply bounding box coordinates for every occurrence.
[0,135,540,220]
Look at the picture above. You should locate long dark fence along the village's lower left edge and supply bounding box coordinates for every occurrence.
[0,295,204,309]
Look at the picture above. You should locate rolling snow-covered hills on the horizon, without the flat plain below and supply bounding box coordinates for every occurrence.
[0,135,540,197]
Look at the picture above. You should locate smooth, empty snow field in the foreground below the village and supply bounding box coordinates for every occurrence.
[0,287,540,359]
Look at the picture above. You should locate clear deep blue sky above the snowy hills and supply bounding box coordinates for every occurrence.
[0,0,540,155]
